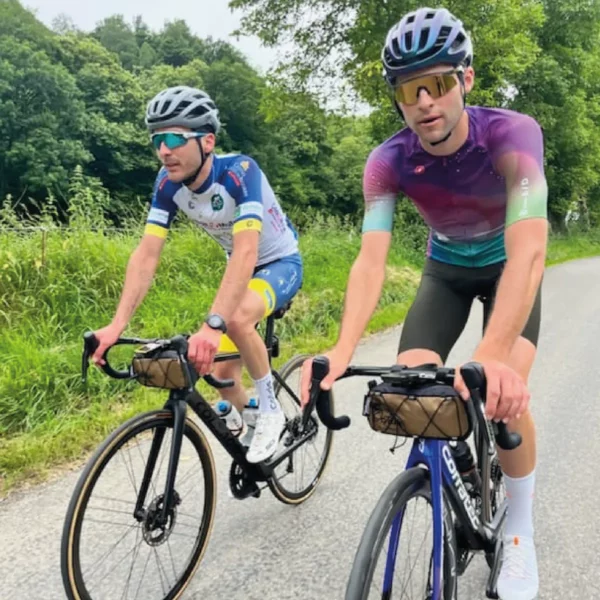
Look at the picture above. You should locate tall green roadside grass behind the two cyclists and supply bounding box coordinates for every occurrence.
[0,188,600,494]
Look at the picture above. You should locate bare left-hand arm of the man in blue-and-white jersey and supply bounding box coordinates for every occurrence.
[93,234,165,364]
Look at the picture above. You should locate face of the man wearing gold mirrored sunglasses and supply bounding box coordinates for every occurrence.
[395,65,474,144]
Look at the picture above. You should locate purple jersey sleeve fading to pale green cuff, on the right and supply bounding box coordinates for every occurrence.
[490,114,548,227]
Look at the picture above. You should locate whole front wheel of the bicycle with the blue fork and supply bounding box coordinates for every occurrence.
[345,468,457,600]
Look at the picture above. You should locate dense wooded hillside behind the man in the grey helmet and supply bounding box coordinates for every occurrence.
[0,0,374,224]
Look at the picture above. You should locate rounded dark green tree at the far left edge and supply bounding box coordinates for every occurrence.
[0,36,92,206]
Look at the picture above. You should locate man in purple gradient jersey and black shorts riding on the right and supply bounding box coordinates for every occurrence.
[302,8,547,600]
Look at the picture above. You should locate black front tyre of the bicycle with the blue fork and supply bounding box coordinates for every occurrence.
[345,467,458,600]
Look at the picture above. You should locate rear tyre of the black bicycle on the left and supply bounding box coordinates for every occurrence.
[267,354,334,504]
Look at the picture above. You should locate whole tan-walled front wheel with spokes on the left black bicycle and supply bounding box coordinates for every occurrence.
[61,410,215,600]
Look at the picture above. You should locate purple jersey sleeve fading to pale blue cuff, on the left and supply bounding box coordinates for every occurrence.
[362,147,399,233]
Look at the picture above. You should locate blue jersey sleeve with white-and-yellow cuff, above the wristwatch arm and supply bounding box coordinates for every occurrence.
[224,156,264,235]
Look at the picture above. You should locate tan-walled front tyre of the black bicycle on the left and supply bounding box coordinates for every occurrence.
[61,409,216,600]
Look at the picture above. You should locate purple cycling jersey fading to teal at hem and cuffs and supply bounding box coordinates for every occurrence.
[363,107,548,266]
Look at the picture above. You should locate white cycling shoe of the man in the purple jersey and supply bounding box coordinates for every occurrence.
[498,535,539,600]
